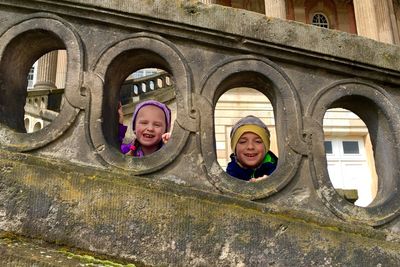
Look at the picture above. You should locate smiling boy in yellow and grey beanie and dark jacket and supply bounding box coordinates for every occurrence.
[226,115,278,182]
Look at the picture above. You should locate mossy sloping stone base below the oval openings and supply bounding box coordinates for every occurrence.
[0,152,400,266]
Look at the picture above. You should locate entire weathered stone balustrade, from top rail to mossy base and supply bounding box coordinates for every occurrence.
[0,0,400,266]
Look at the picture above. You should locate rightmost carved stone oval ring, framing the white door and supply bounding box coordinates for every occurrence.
[306,80,400,226]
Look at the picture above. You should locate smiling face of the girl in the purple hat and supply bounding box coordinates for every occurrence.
[135,105,166,155]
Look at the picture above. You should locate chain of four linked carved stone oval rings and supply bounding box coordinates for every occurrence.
[0,11,398,216]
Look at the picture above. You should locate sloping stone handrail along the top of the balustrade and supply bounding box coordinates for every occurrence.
[14,0,400,71]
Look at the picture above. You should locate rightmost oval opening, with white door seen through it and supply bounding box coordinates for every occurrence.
[323,108,378,207]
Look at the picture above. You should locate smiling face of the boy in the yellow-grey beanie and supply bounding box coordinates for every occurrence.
[235,132,266,168]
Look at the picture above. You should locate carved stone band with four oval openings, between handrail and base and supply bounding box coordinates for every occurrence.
[0,0,400,243]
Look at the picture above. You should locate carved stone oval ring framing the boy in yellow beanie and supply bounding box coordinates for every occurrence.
[195,56,306,199]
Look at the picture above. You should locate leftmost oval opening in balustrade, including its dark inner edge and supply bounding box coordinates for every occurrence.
[0,29,66,133]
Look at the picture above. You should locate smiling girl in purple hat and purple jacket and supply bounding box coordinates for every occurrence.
[118,100,171,157]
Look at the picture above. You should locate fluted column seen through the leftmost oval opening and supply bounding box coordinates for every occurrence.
[34,51,58,89]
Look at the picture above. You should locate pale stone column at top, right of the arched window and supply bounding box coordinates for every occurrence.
[353,0,394,44]
